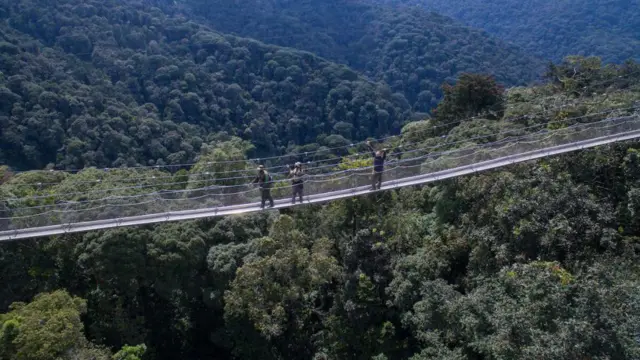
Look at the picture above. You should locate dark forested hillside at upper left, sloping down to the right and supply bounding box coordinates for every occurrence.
[0,0,411,169]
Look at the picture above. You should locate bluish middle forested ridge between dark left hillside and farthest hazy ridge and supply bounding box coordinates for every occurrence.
[168,0,544,112]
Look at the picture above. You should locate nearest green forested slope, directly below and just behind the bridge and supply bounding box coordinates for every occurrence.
[0,58,640,360]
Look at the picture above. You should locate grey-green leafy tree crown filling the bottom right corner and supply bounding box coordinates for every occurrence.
[451,261,640,359]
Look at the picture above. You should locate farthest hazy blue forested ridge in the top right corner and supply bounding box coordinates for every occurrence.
[376,0,640,63]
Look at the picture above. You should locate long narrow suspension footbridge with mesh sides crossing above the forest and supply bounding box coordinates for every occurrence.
[0,113,640,241]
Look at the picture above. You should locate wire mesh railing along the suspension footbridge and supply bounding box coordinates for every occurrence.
[0,115,640,235]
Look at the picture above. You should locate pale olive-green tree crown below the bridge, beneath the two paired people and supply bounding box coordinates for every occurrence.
[225,216,339,339]
